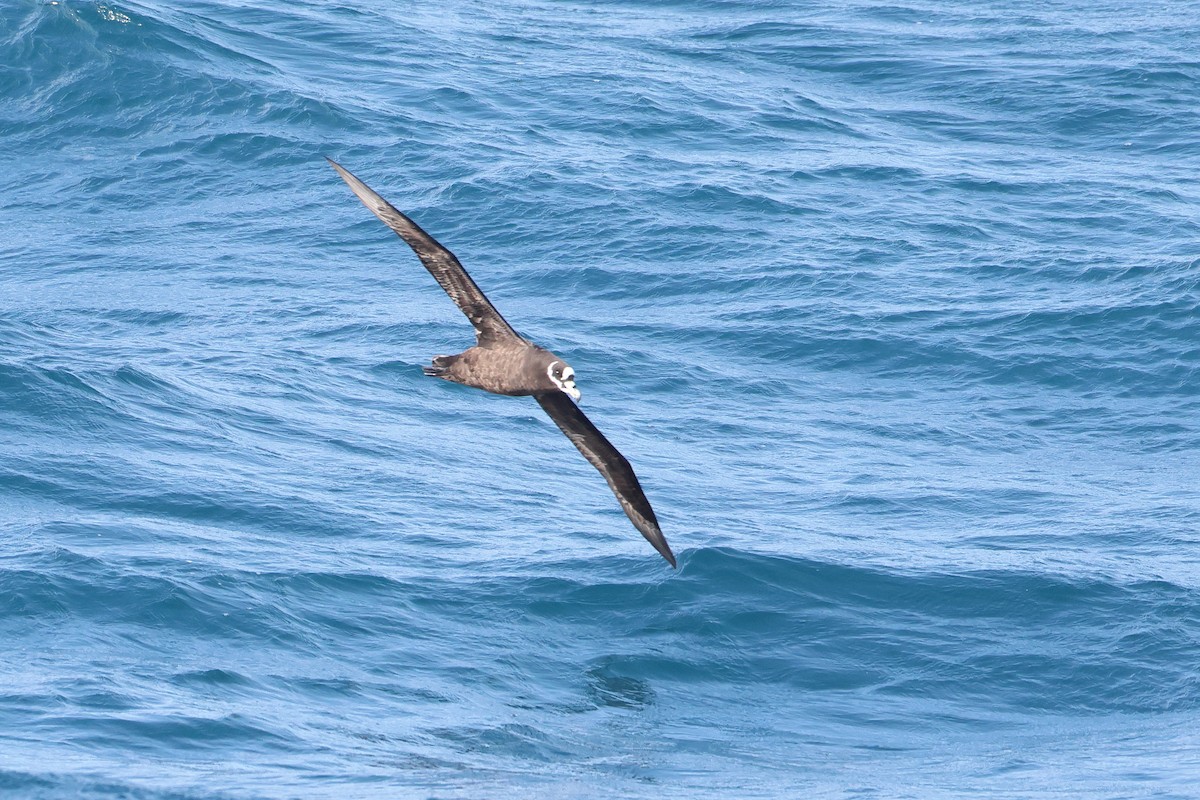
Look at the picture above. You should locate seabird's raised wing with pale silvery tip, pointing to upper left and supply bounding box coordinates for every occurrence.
[325,158,521,344]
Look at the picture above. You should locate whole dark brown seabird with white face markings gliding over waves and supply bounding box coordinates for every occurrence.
[326,158,676,566]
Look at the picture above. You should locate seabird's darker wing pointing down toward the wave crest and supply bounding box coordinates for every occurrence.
[534,392,676,566]
